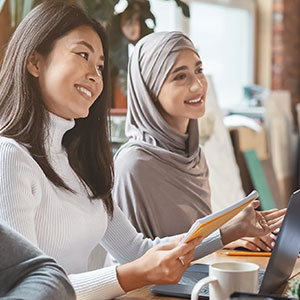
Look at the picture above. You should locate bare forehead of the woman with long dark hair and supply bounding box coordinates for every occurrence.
[55,25,104,56]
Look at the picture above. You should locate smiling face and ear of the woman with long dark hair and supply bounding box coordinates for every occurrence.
[27,26,104,119]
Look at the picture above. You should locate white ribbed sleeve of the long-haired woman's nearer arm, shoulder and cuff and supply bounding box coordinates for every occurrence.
[0,139,124,300]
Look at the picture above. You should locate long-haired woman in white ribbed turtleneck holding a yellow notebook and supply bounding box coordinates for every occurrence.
[0,1,282,299]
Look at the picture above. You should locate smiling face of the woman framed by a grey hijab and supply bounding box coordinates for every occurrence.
[156,49,207,133]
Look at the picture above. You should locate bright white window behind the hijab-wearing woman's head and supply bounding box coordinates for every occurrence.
[150,0,255,109]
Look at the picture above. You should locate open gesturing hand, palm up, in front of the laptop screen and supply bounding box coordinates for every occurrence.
[221,200,286,245]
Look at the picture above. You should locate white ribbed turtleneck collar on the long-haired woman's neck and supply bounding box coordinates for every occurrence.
[45,112,75,153]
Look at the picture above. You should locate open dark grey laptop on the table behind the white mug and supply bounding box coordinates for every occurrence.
[150,190,300,299]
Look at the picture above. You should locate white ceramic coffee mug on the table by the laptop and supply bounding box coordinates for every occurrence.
[191,262,259,300]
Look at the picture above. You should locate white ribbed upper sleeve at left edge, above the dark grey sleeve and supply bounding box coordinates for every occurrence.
[0,142,40,245]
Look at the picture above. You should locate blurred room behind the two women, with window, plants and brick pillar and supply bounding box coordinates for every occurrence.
[0,0,300,210]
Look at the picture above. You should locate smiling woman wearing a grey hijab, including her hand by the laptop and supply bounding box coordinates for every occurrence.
[113,31,282,250]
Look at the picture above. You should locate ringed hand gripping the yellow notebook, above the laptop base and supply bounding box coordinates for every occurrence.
[117,238,202,292]
